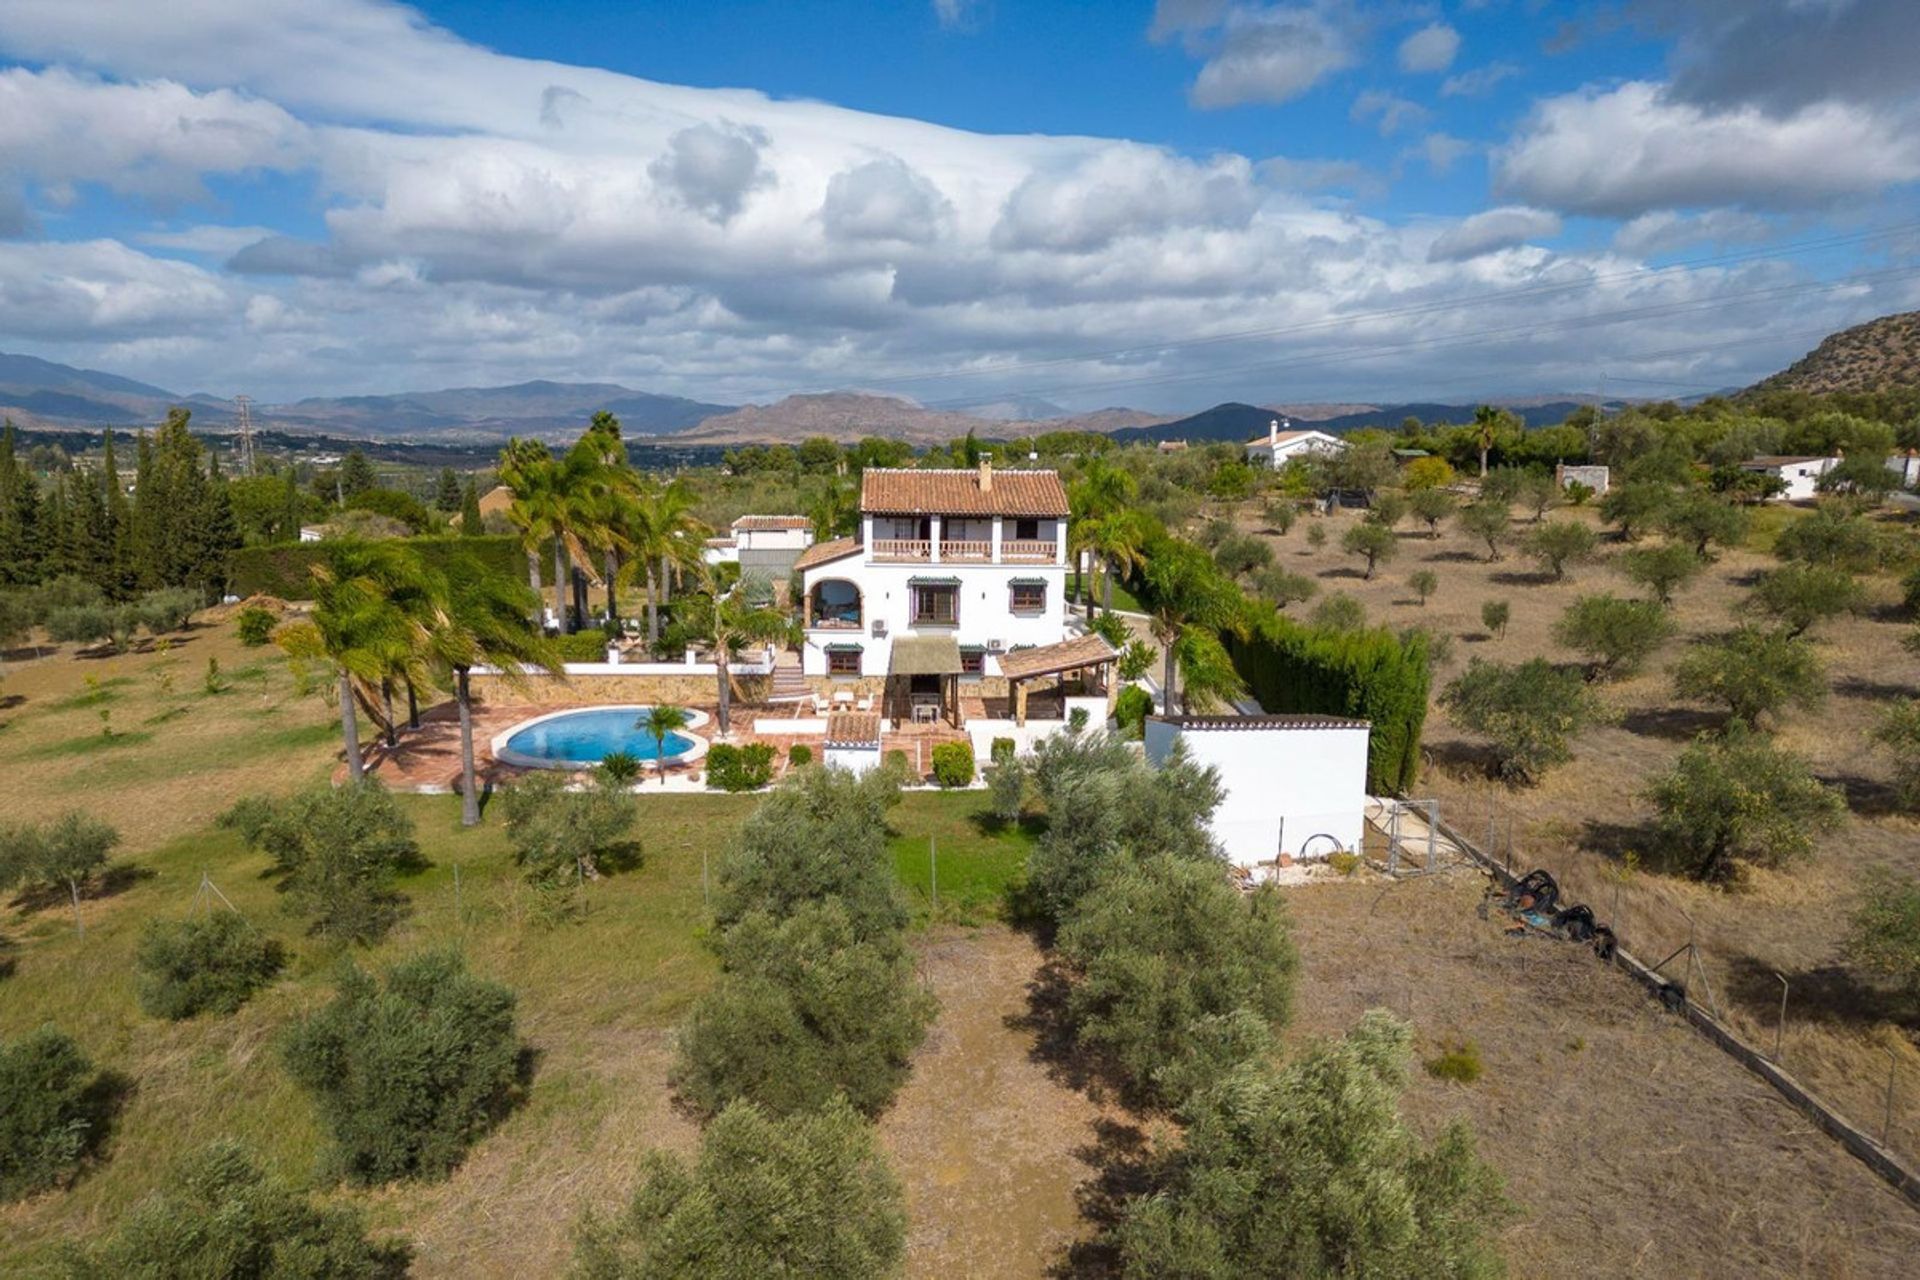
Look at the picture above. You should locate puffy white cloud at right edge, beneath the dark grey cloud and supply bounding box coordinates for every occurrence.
[1494,81,1920,217]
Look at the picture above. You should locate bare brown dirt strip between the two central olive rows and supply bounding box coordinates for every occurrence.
[879,925,1102,1276]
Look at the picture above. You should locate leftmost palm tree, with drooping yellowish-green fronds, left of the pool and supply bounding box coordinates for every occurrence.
[275,539,445,783]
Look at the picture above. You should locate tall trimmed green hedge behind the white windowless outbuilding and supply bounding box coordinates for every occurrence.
[1221,614,1432,793]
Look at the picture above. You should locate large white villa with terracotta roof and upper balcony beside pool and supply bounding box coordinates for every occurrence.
[797,461,1082,723]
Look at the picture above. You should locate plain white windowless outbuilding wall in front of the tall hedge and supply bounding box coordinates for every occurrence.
[1146,716,1369,867]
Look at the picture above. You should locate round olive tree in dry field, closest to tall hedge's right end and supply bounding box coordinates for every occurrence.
[1440,658,1601,783]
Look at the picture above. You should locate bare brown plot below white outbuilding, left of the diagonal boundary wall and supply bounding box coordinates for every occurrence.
[1288,873,1920,1276]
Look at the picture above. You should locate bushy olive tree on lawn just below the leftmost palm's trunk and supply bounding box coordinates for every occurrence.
[221,781,424,944]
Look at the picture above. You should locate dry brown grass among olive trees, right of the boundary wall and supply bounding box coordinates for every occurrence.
[1240,507,1920,1159]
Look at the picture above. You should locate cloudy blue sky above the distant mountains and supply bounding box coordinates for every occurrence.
[0,0,1920,409]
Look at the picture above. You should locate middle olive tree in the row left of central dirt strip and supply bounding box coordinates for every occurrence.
[672,900,937,1115]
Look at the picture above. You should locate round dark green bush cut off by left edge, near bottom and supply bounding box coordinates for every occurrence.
[0,1027,109,1203]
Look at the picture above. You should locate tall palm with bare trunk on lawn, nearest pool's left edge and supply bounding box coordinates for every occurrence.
[430,557,564,827]
